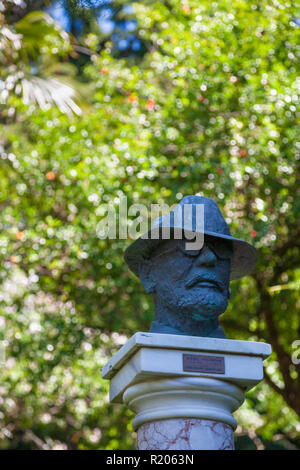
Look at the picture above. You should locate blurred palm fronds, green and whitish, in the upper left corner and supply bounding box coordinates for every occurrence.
[0,6,81,115]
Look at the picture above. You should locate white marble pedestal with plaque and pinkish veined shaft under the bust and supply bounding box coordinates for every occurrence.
[102,333,271,450]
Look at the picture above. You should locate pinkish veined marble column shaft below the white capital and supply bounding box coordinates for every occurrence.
[137,419,234,450]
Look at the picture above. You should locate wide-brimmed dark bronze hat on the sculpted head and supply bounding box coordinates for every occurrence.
[124,196,257,279]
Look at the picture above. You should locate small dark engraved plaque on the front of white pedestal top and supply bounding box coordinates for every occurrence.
[182,354,225,374]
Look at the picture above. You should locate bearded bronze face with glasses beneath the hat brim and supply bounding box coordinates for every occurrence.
[141,236,232,329]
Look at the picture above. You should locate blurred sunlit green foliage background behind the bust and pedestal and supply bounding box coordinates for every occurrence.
[0,0,300,450]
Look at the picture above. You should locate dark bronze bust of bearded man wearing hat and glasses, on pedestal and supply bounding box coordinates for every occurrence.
[125,196,257,338]
